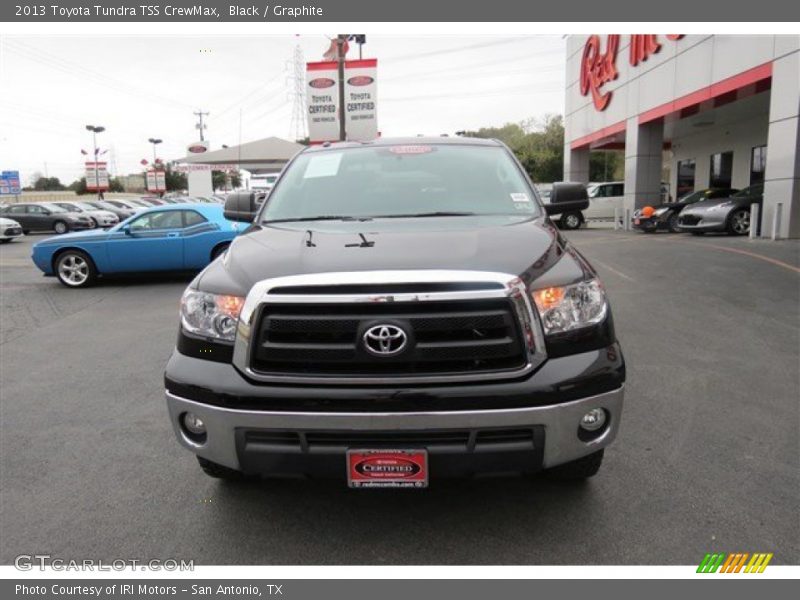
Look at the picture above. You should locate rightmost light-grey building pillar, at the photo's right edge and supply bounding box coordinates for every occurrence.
[761,51,800,238]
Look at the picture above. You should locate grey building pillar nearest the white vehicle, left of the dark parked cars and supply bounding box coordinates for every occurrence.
[624,117,664,212]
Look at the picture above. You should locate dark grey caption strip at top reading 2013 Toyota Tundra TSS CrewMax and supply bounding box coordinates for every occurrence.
[0,0,800,23]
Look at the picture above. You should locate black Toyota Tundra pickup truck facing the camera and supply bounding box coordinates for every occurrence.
[165,138,625,488]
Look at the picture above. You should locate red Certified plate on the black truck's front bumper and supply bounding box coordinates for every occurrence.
[347,449,428,488]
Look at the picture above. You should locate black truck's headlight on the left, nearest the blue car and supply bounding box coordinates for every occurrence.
[181,288,244,342]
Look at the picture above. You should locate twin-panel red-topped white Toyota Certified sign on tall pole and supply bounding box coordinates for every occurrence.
[306,58,378,143]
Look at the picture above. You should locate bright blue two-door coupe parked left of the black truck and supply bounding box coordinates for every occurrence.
[32,204,244,288]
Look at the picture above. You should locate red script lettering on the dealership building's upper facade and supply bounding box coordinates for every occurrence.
[580,34,683,110]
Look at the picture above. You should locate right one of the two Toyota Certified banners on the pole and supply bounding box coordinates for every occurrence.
[344,58,378,142]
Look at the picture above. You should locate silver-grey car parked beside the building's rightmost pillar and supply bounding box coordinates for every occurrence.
[678,183,764,235]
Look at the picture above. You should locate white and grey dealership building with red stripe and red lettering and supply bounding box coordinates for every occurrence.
[564,35,800,238]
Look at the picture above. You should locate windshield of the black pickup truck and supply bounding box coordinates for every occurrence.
[262,144,539,222]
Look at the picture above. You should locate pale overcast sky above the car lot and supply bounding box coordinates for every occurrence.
[0,34,566,184]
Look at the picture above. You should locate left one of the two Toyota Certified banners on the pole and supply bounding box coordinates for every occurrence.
[306,61,339,144]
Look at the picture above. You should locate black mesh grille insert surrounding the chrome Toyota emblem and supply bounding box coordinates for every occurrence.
[251,299,525,377]
